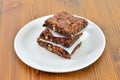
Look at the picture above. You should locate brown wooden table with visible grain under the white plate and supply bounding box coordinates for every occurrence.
[0,0,120,80]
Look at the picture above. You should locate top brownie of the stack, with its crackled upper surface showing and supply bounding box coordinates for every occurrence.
[43,11,88,37]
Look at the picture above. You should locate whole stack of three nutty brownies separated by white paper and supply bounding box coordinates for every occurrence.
[37,12,88,59]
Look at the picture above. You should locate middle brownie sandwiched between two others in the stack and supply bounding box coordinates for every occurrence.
[38,28,82,48]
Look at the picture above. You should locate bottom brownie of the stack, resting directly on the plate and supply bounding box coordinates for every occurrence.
[38,39,81,59]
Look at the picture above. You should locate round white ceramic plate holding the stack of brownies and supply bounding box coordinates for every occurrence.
[14,15,105,73]
